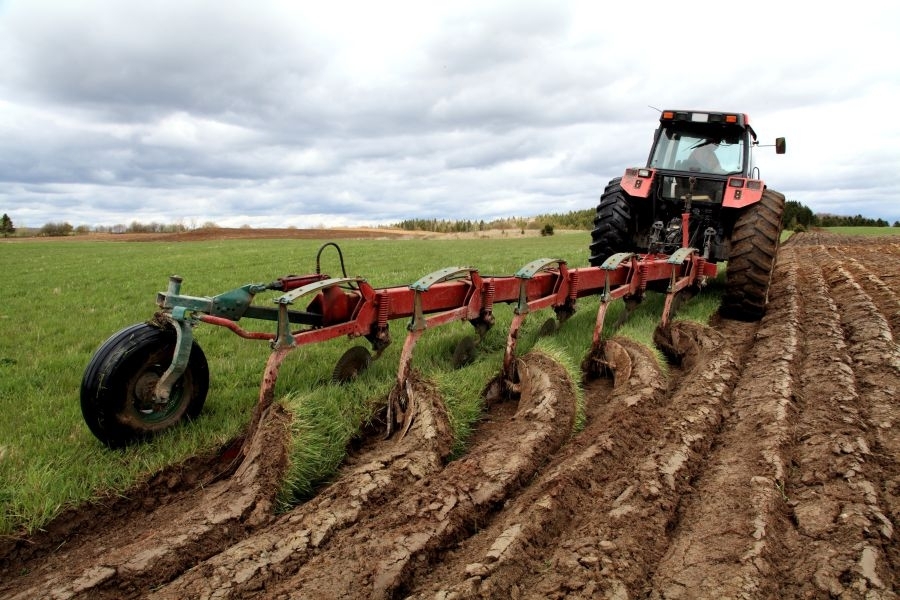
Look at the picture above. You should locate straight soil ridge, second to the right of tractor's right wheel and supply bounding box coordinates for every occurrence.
[782,251,896,597]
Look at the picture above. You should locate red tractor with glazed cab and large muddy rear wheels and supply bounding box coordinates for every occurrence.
[590,110,785,321]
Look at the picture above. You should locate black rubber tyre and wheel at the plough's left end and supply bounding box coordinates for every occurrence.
[81,323,209,448]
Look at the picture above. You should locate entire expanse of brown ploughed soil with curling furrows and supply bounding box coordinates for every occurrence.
[0,232,900,599]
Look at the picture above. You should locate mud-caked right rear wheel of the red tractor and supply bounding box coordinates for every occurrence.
[719,189,784,321]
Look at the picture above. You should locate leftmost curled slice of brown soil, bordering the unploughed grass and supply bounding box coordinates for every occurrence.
[0,406,290,600]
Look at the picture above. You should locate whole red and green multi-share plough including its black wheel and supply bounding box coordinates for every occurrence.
[81,232,716,447]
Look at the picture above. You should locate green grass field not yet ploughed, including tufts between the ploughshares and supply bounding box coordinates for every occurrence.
[0,233,721,534]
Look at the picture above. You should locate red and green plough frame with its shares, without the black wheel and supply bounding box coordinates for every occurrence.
[132,239,716,446]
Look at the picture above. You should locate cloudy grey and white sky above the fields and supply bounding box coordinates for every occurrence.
[0,0,900,227]
